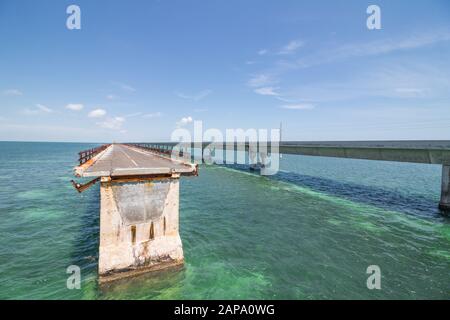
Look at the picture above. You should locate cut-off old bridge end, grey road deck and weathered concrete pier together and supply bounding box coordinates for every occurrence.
[75,144,197,282]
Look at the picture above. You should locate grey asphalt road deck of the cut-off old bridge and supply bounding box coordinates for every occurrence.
[75,144,196,177]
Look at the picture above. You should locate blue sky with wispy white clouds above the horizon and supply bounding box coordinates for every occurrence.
[0,0,450,142]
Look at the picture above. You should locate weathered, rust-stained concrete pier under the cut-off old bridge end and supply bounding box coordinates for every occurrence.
[98,174,183,282]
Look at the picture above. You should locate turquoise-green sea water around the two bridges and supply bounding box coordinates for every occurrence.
[0,142,450,299]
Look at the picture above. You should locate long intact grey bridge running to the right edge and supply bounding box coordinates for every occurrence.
[127,140,450,212]
